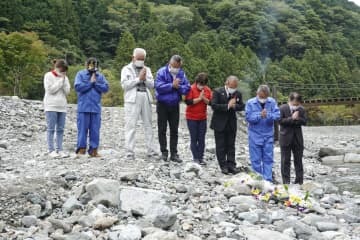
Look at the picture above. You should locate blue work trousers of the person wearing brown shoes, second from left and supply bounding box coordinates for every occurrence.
[76,112,101,153]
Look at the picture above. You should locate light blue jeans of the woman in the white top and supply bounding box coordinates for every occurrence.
[45,111,66,152]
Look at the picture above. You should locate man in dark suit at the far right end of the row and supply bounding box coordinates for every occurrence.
[279,93,306,184]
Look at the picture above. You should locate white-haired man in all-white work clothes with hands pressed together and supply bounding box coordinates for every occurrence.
[121,48,159,160]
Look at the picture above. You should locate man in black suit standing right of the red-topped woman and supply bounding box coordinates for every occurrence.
[210,76,244,174]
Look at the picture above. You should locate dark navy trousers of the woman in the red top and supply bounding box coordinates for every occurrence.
[187,120,207,160]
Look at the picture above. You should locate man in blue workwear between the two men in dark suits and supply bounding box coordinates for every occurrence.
[245,85,280,182]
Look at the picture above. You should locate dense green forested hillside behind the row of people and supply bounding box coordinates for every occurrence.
[0,0,360,105]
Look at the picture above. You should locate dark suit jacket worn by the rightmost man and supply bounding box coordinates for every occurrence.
[279,104,306,147]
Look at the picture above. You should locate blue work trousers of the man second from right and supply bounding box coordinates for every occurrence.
[249,137,274,182]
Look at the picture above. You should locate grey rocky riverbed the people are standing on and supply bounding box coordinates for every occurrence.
[0,97,360,240]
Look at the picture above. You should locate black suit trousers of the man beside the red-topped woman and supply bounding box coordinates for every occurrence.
[214,128,236,169]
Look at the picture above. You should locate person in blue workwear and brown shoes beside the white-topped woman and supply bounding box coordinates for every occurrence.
[74,58,109,157]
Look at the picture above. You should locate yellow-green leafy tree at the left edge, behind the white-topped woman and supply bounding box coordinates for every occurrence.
[0,32,47,98]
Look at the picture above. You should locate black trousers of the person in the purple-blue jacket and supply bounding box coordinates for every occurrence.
[156,102,180,155]
